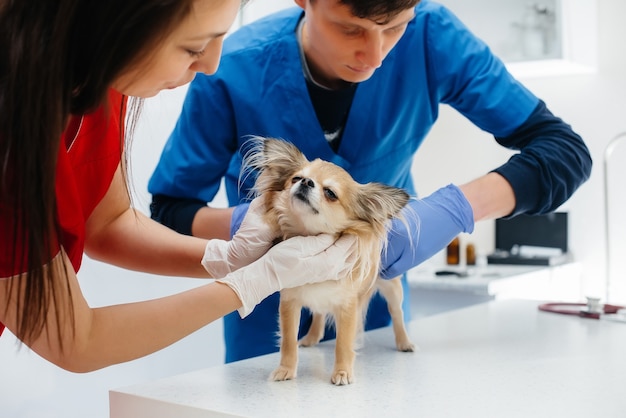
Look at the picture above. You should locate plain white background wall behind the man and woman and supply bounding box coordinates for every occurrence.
[0,0,626,418]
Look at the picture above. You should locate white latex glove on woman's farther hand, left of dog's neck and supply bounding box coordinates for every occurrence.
[202,198,279,279]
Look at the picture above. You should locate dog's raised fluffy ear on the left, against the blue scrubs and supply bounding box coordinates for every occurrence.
[243,137,309,194]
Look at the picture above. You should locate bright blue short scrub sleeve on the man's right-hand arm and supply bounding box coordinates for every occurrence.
[418,2,539,136]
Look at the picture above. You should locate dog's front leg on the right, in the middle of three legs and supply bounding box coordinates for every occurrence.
[330,300,360,386]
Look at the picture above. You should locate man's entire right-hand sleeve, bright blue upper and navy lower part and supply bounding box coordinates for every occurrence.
[421,2,592,216]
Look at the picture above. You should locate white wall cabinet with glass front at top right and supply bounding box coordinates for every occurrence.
[439,0,598,78]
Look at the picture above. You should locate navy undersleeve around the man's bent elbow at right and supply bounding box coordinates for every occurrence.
[494,102,592,216]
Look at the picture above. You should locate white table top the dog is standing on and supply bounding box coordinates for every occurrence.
[110,300,626,418]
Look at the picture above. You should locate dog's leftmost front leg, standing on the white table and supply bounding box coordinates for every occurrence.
[270,293,302,381]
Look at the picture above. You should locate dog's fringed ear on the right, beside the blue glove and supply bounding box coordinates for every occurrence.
[355,183,409,224]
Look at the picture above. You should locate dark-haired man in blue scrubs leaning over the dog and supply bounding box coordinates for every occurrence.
[149,0,591,361]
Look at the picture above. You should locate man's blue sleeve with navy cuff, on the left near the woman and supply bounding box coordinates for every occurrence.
[148,74,238,234]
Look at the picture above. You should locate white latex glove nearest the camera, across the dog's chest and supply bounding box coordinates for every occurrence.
[217,234,356,318]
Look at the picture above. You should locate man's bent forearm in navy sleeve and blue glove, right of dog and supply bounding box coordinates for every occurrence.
[381,102,592,278]
